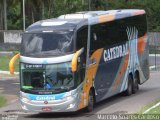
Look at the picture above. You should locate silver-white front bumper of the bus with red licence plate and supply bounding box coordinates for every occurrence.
[20,95,78,112]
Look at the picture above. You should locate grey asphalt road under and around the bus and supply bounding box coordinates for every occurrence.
[0,72,160,120]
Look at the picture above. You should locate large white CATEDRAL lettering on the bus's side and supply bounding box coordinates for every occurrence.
[103,43,129,62]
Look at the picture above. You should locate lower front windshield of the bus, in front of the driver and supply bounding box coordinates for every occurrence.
[21,62,75,93]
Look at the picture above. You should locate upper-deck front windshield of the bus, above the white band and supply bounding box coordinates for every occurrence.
[21,31,74,57]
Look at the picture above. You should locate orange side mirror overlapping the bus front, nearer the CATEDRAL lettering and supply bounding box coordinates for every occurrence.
[71,48,84,72]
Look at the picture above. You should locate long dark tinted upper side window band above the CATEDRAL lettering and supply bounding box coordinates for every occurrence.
[90,15,147,54]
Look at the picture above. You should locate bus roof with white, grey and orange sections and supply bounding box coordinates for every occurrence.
[26,9,145,32]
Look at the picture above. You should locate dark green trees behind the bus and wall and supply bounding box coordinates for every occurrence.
[0,0,160,31]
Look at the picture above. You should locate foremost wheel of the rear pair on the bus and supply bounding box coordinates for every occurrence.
[125,75,133,96]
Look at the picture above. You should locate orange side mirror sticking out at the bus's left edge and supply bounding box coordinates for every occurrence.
[9,53,20,74]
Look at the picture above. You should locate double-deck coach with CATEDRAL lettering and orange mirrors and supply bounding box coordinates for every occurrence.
[9,9,149,113]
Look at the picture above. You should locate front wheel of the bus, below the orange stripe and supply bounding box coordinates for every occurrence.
[86,89,94,112]
